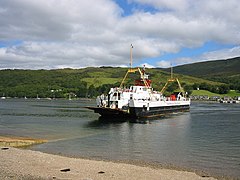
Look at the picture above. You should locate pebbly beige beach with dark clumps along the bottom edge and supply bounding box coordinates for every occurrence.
[0,147,218,180]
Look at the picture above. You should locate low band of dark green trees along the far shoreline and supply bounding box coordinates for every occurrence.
[0,81,230,98]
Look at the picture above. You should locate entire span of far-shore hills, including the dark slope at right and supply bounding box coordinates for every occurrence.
[0,57,240,98]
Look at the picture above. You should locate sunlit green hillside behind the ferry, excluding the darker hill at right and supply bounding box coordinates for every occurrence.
[0,67,222,98]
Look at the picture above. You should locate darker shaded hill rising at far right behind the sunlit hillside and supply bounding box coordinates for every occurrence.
[163,57,240,89]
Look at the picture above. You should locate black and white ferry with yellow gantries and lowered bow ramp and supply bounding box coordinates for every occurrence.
[87,45,190,119]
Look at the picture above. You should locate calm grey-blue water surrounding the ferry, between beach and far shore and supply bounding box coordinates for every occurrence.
[0,99,240,178]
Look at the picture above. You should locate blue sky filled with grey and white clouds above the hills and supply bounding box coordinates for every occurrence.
[0,0,240,69]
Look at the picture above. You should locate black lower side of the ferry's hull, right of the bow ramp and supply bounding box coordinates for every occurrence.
[129,105,190,119]
